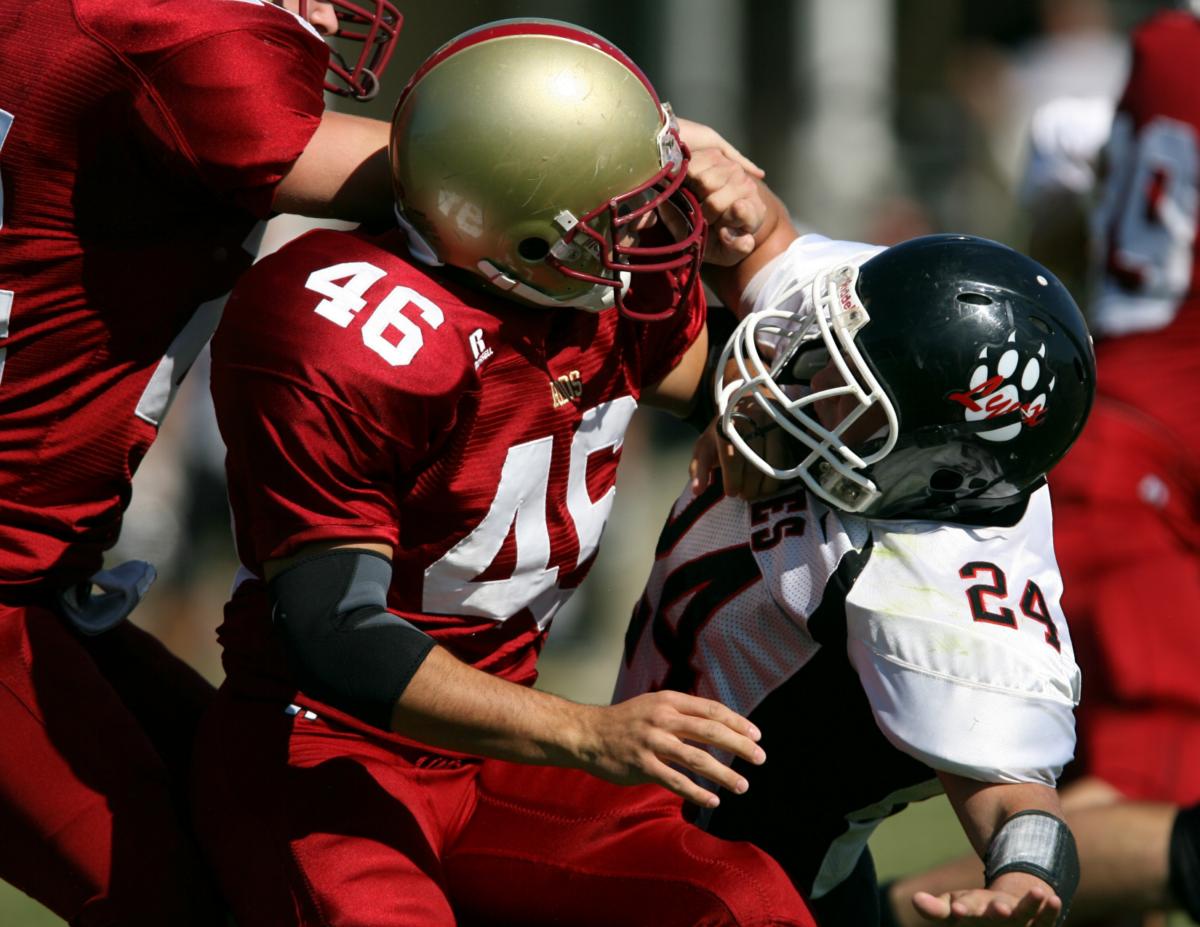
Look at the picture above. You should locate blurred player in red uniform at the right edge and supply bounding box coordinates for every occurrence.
[890,7,1200,925]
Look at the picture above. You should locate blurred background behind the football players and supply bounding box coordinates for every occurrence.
[0,0,1190,927]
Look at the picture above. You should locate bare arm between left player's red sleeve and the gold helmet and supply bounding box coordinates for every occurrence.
[274,112,392,222]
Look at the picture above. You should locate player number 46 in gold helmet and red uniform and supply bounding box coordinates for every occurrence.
[193,20,812,927]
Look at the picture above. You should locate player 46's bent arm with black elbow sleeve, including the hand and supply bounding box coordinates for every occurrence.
[263,539,766,807]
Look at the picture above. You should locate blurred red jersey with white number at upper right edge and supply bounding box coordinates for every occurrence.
[1090,11,1200,335]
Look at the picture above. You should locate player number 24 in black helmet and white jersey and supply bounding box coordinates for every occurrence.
[616,189,1094,927]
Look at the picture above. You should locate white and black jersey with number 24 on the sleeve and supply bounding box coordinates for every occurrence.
[614,482,1080,899]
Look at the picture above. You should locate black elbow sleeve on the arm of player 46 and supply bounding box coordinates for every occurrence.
[266,548,433,730]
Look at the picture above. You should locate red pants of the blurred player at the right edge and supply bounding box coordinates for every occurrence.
[1050,398,1200,806]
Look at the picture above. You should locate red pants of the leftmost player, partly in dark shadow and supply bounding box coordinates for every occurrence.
[0,604,224,927]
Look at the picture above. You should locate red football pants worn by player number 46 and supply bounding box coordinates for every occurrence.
[192,689,814,927]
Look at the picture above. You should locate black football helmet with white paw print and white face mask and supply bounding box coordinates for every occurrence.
[716,235,1096,519]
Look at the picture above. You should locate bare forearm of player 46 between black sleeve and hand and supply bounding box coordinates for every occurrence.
[391,647,596,766]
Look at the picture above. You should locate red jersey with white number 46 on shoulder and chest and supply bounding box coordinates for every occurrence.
[212,226,704,682]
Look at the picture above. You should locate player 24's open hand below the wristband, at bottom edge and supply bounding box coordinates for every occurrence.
[912,872,1062,927]
